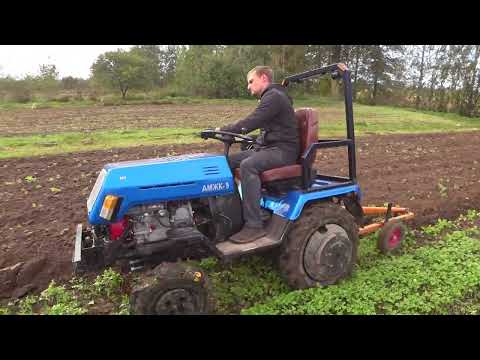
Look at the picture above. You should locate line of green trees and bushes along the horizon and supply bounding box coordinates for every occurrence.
[0,45,480,116]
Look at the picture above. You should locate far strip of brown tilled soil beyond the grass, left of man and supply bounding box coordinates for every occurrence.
[0,104,254,136]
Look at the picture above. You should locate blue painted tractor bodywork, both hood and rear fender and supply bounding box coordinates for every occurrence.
[87,153,360,225]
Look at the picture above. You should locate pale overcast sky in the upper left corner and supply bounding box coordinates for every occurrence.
[0,45,132,79]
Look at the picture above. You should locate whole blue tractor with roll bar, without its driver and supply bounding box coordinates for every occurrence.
[73,64,363,314]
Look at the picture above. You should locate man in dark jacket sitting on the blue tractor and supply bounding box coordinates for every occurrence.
[219,66,299,244]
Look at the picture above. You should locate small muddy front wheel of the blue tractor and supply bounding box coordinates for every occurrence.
[130,263,211,315]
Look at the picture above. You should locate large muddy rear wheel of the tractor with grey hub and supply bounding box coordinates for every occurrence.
[279,202,358,289]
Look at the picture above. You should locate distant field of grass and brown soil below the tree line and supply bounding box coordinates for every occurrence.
[0,98,480,158]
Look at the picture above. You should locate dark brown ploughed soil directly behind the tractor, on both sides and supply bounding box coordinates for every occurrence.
[0,131,480,298]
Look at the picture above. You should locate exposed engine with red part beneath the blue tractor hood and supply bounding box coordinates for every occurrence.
[91,194,243,271]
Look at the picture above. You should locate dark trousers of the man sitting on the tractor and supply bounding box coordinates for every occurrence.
[229,147,298,228]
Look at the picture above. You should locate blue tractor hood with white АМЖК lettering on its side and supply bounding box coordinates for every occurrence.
[87,153,234,224]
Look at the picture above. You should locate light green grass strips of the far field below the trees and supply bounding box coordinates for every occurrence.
[0,97,480,158]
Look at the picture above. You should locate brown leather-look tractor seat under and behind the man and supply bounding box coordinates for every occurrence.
[235,108,318,183]
